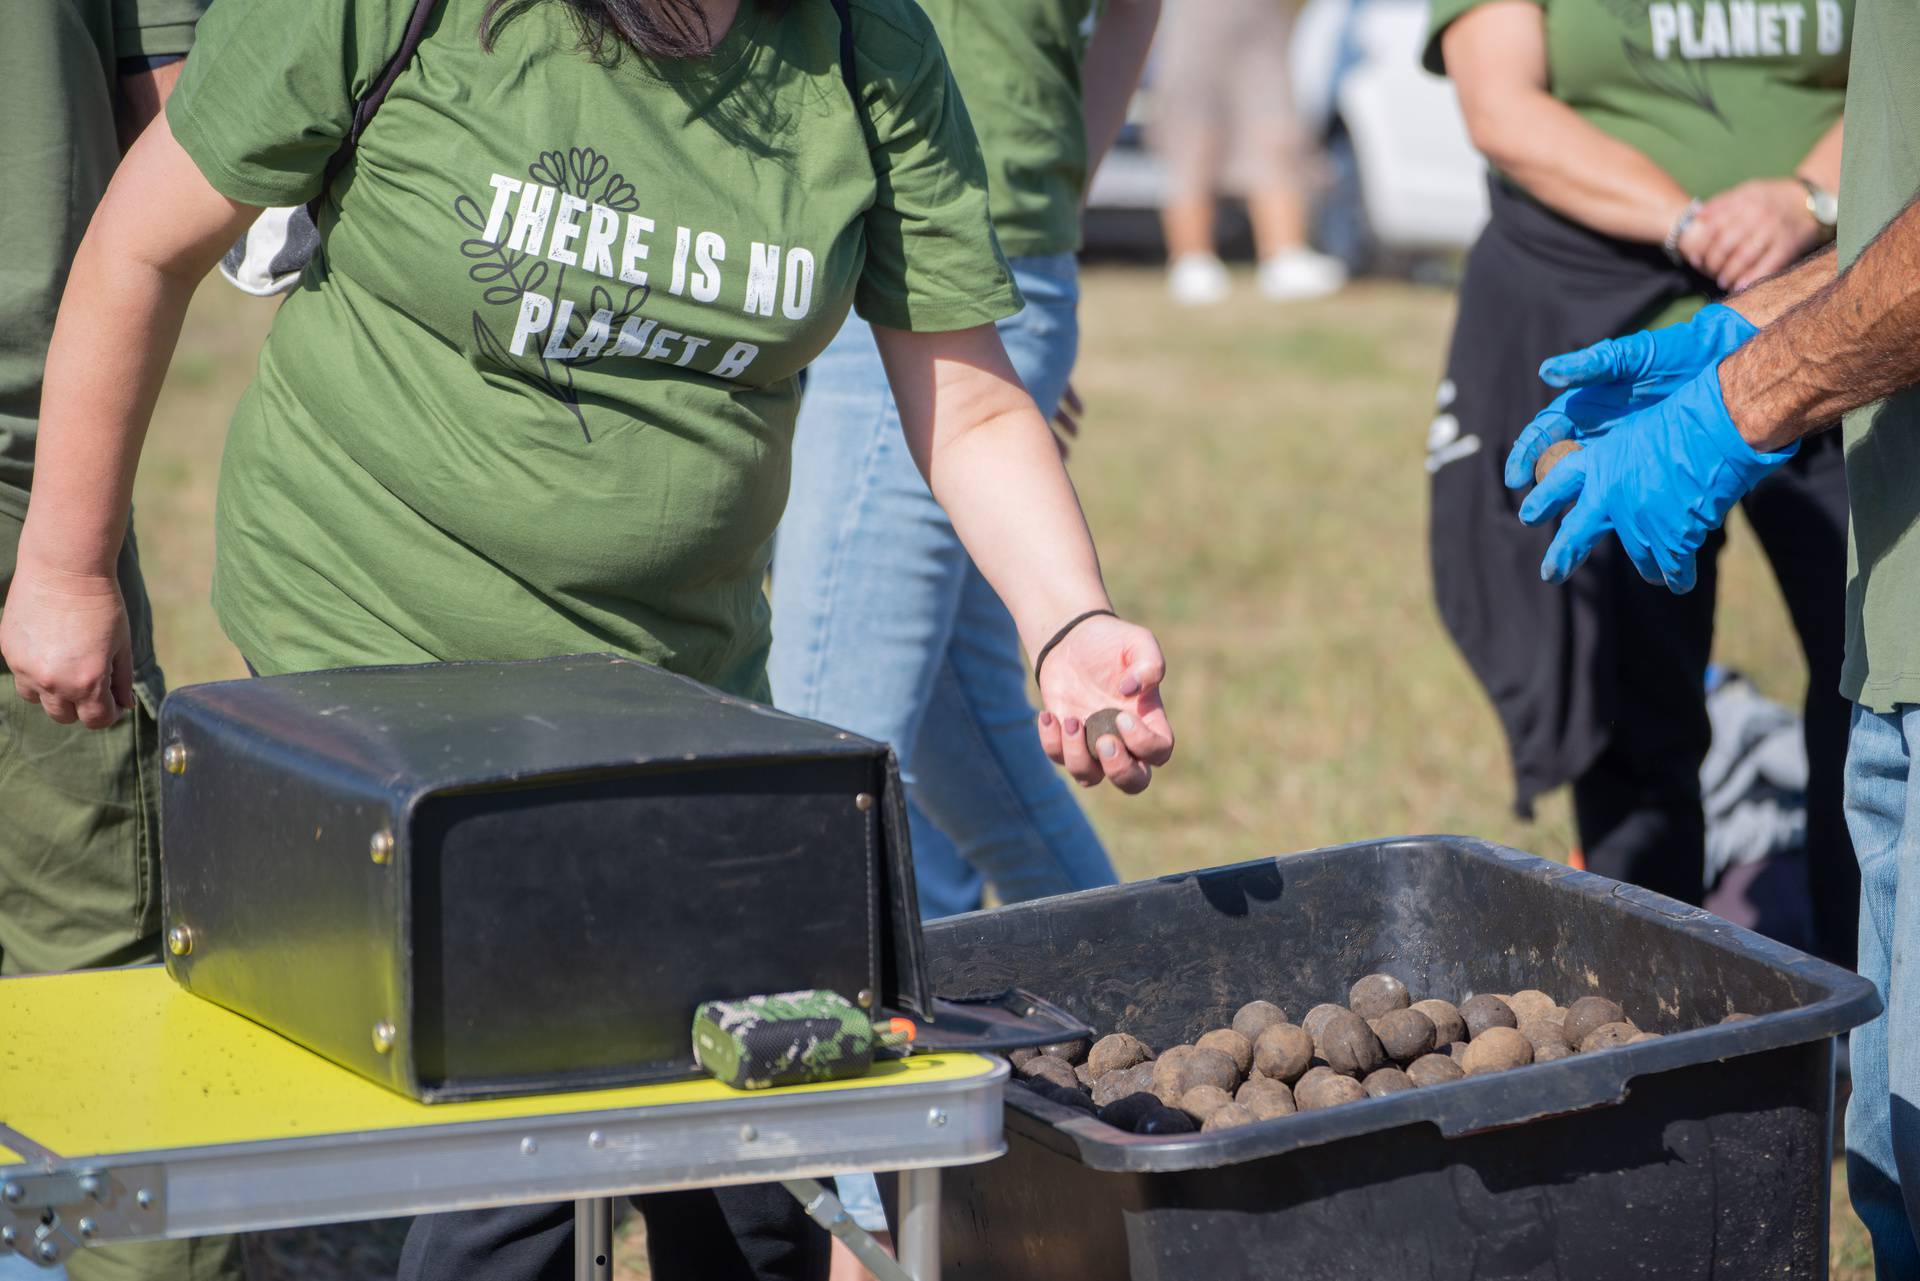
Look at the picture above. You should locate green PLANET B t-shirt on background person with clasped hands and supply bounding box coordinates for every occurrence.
[1425,0,1853,198]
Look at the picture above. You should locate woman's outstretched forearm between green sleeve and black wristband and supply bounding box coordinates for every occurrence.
[874,325,1110,655]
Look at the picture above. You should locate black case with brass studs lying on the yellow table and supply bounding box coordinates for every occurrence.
[161,655,1006,1100]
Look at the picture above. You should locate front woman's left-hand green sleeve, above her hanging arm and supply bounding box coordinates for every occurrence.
[167,0,411,205]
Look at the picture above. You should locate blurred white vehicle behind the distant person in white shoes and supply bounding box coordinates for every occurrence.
[1087,0,1486,269]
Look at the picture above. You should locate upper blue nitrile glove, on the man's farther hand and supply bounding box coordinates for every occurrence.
[1507,303,1761,490]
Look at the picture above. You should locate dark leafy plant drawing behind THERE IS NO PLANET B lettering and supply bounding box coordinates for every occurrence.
[453,148,651,444]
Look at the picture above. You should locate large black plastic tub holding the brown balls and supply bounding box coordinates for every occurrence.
[910,837,1880,1281]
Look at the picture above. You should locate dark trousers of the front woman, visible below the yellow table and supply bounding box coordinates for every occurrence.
[397,1183,828,1281]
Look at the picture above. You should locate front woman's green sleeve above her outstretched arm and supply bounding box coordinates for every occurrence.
[854,0,1021,332]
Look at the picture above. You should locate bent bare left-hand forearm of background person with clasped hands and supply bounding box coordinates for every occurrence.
[1440,0,1692,244]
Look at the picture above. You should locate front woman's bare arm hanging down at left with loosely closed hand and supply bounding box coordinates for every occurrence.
[0,115,259,728]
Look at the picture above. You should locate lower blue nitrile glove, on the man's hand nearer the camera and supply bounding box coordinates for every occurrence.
[1521,361,1799,592]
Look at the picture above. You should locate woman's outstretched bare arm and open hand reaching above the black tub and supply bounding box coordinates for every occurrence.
[874,325,1173,791]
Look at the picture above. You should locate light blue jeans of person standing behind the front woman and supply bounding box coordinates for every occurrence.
[768,254,1116,918]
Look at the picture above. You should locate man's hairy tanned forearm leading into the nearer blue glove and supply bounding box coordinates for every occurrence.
[1720,190,1920,449]
